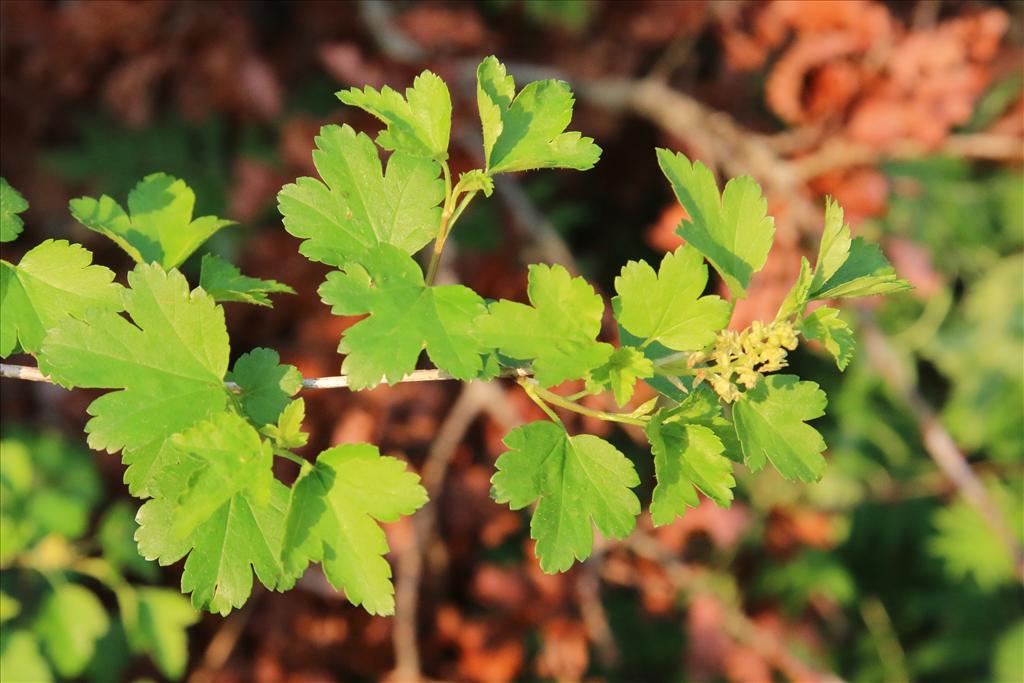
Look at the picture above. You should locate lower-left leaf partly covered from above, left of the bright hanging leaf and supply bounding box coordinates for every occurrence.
[135,478,294,615]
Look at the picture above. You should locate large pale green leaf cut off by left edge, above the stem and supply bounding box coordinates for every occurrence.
[0,240,122,357]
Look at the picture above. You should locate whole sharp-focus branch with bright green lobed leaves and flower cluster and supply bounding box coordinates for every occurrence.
[0,57,907,614]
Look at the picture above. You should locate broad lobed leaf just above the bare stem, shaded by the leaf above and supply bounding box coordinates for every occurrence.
[318,245,486,389]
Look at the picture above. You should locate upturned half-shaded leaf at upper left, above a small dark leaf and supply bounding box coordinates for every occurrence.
[70,173,234,270]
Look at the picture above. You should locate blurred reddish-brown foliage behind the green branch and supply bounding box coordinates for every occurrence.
[0,0,1024,683]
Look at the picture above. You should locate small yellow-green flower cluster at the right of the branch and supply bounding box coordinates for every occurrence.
[688,321,798,403]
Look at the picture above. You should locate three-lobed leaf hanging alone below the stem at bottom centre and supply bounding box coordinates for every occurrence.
[490,422,640,573]
